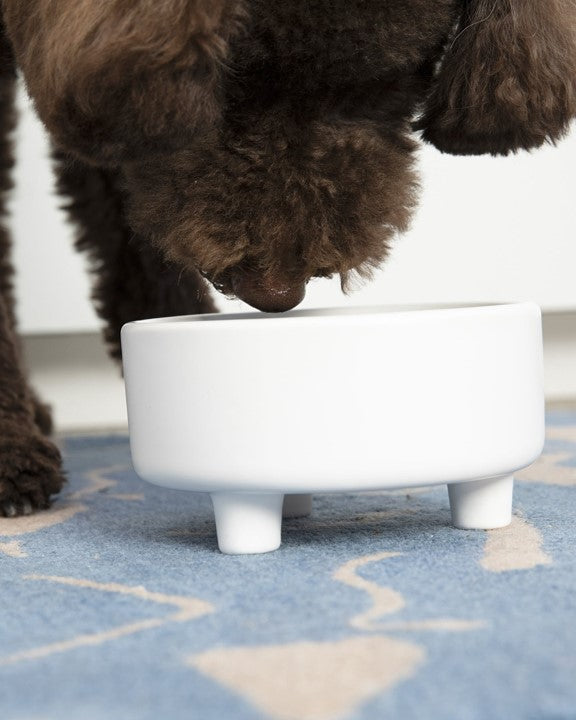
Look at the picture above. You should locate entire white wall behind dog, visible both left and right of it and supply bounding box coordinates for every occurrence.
[12,81,576,333]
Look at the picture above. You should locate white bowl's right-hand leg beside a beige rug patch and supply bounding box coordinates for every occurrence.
[448,475,514,530]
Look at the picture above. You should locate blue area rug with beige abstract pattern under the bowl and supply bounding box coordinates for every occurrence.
[0,412,576,720]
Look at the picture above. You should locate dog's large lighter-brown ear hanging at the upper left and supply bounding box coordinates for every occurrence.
[2,0,244,165]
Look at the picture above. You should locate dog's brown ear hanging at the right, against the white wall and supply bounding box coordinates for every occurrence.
[415,0,576,155]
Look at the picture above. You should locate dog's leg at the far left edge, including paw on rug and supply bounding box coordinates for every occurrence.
[0,19,64,516]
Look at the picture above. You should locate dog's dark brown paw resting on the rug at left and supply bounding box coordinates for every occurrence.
[0,435,65,517]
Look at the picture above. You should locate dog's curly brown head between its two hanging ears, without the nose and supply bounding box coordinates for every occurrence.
[123,0,456,301]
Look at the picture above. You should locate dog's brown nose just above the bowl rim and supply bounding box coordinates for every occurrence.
[232,270,306,312]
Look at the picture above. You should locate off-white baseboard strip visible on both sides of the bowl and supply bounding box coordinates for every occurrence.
[24,312,576,432]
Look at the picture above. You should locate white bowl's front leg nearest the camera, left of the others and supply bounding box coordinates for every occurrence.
[211,492,284,555]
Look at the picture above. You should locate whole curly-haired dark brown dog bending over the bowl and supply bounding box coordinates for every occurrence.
[0,0,576,516]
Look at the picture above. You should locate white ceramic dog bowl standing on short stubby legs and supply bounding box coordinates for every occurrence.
[122,303,544,553]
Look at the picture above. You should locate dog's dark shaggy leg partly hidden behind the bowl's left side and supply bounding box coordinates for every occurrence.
[54,152,216,358]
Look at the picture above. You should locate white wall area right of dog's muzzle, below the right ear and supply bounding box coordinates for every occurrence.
[296,129,576,316]
